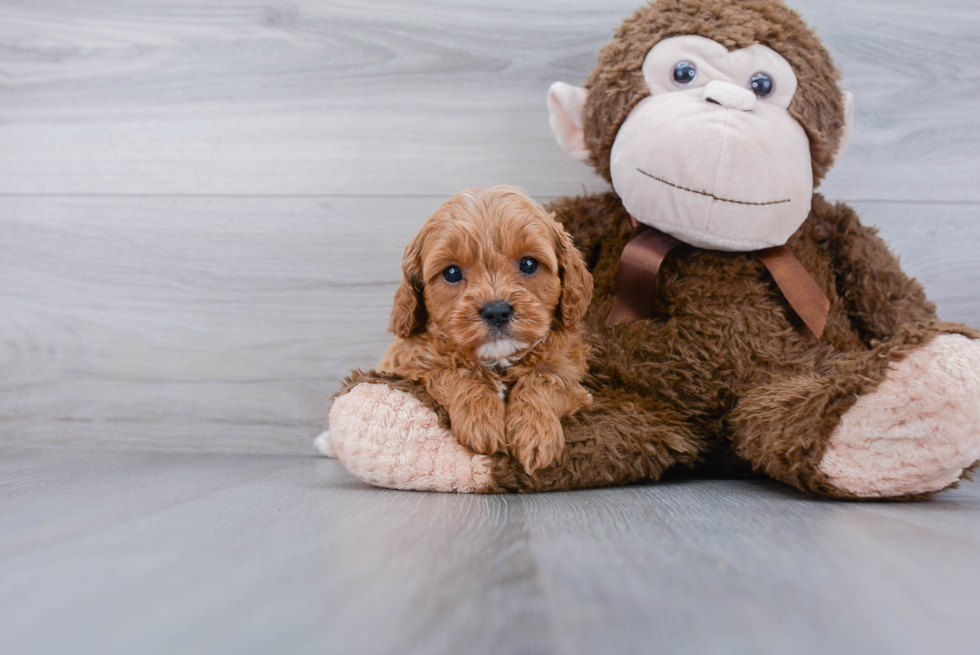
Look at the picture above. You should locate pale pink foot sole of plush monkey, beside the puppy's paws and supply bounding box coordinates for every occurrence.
[330,382,492,493]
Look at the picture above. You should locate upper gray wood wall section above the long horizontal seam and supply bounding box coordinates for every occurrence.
[0,0,980,201]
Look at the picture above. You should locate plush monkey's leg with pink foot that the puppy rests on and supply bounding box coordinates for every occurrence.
[330,374,701,493]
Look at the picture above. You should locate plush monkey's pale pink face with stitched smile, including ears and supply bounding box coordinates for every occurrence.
[548,35,851,251]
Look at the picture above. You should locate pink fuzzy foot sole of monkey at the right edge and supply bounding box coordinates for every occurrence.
[820,334,980,498]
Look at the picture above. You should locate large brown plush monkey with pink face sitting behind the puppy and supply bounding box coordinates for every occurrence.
[331,0,980,498]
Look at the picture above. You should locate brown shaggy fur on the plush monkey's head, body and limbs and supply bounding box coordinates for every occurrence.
[334,0,980,498]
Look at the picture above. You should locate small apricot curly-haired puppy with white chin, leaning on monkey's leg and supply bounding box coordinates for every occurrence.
[380,186,592,472]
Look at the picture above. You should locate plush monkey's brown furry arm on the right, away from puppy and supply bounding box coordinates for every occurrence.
[813,196,936,341]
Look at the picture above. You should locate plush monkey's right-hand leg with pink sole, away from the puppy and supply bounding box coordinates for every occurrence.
[732,321,980,499]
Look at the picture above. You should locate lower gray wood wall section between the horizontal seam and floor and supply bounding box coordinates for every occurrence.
[0,197,980,454]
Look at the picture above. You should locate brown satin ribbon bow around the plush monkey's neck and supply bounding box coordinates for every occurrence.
[606,222,830,339]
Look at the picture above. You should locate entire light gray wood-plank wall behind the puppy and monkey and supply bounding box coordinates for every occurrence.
[0,0,980,454]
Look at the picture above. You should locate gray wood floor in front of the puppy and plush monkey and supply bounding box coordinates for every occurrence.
[0,451,980,655]
